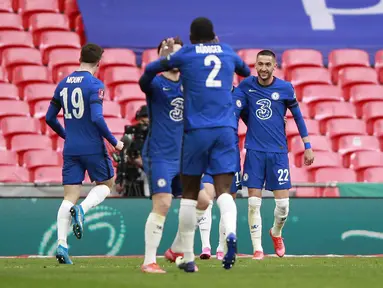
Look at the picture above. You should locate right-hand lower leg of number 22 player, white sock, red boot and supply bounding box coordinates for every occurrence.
[270,190,289,257]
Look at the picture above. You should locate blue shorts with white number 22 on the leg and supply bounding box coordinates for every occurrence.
[243,150,291,191]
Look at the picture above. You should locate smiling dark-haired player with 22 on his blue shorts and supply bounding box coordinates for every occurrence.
[238,50,314,260]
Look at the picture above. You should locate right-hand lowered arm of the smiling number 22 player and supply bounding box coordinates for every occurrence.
[287,86,314,166]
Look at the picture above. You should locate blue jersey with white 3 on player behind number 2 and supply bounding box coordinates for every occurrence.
[141,75,184,161]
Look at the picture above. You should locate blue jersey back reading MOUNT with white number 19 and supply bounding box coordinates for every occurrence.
[56,71,106,155]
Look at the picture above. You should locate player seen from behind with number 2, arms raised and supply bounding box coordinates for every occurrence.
[143,17,250,272]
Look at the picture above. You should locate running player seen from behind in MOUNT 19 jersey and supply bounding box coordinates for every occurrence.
[46,43,124,264]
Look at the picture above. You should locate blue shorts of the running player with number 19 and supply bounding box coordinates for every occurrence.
[62,153,114,185]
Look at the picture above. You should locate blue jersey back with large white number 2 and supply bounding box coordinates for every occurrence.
[176,43,241,130]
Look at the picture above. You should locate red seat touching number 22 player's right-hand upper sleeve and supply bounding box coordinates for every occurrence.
[297,85,344,107]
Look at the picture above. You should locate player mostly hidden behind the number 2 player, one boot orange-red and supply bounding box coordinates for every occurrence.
[140,38,210,273]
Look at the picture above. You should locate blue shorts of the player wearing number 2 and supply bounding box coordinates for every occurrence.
[181,127,237,176]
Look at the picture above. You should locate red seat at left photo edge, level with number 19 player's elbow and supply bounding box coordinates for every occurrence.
[1,117,40,141]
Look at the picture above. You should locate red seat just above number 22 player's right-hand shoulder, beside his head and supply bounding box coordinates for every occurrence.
[291,67,331,99]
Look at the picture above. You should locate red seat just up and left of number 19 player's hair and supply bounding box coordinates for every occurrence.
[39,31,81,63]
